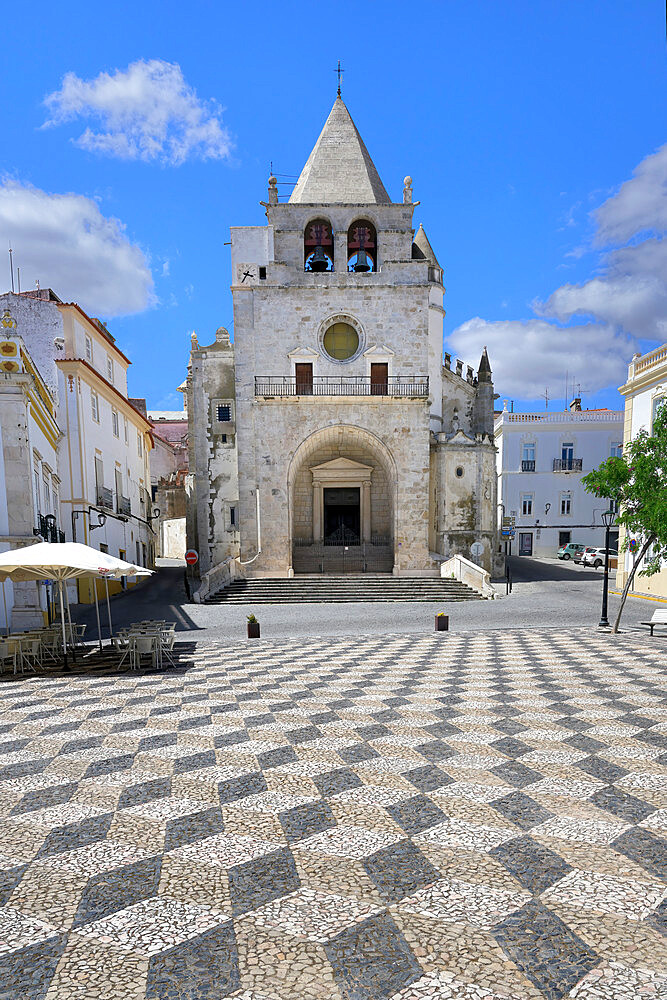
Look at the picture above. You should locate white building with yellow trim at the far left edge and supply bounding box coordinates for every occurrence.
[0,310,62,632]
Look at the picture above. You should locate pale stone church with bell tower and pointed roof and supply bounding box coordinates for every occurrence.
[187,96,499,590]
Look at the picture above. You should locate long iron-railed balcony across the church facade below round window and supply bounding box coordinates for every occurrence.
[255,375,428,399]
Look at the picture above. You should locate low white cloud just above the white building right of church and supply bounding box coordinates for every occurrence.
[449,317,636,399]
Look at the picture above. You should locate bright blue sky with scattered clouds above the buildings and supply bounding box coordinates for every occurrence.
[0,0,667,409]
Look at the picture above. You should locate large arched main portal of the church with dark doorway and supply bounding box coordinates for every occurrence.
[288,424,397,573]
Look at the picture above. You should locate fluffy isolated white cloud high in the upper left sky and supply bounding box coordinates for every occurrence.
[44,59,233,166]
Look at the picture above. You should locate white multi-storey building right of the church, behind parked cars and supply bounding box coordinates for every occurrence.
[495,399,623,556]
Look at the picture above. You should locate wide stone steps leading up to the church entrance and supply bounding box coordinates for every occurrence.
[206,574,483,604]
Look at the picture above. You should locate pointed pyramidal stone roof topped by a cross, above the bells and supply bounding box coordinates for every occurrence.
[290,97,391,205]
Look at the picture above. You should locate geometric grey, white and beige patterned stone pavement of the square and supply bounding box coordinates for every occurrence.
[0,629,667,1000]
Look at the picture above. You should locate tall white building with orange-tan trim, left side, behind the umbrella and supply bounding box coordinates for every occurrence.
[0,288,155,602]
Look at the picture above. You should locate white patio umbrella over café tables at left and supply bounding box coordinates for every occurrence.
[0,542,153,668]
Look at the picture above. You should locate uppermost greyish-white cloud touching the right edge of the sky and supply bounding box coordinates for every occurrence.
[595,145,667,246]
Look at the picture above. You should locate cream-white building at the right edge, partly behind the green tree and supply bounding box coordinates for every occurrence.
[616,344,667,598]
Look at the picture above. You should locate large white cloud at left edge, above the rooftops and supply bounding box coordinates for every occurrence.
[0,180,153,316]
